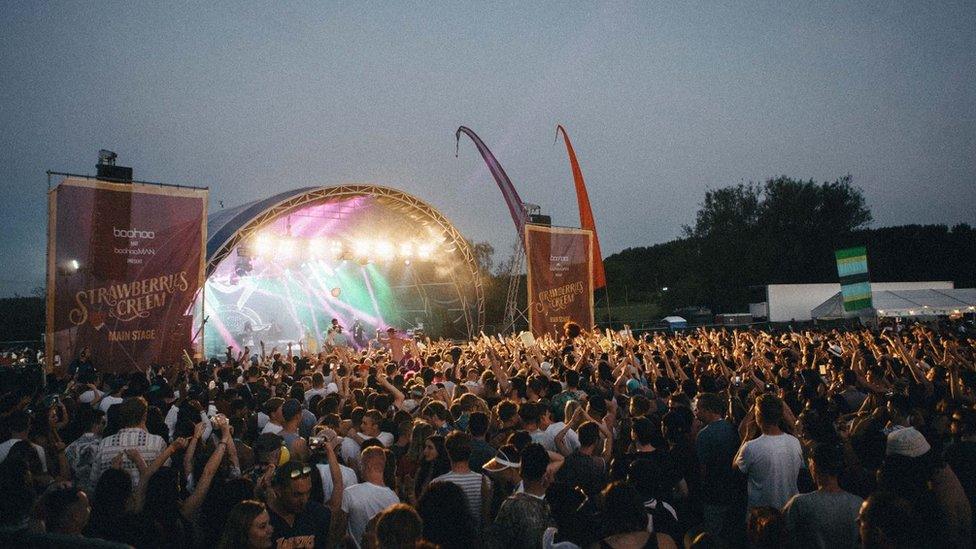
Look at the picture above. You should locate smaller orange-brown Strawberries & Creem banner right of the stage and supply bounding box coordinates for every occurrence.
[525,224,593,336]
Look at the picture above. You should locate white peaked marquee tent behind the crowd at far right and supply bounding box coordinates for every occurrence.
[810,288,976,320]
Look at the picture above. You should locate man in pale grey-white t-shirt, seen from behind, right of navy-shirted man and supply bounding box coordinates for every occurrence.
[733,394,803,509]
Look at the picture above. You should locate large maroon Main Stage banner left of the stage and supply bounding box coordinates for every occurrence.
[45,178,207,372]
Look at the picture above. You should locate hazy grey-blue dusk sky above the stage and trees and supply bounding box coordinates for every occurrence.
[0,0,976,295]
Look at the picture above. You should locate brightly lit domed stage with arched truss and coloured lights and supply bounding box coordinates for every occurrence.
[196,184,484,356]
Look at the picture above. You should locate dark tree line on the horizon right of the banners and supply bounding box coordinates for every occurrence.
[604,176,976,313]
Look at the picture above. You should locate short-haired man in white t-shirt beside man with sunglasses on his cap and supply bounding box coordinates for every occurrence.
[342,446,400,547]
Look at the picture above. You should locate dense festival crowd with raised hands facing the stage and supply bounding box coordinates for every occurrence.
[0,316,976,549]
